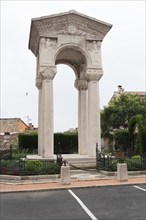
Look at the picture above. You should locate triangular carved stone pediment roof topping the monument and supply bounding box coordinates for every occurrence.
[29,10,112,53]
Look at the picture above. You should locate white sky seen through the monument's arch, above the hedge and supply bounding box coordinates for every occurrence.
[53,64,78,132]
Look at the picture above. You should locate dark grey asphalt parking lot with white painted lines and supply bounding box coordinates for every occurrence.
[0,184,146,220]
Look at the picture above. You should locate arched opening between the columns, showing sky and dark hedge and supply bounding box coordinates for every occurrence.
[53,64,78,154]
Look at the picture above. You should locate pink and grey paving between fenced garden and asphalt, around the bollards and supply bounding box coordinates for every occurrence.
[0,170,146,193]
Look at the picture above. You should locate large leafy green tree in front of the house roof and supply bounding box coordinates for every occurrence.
[101,93,146,151]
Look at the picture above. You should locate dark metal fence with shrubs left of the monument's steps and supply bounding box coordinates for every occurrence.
[0,145,66,176]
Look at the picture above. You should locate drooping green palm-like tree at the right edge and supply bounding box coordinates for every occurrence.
[128,114,146,155]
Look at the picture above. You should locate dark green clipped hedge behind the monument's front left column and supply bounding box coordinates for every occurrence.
[18,132,78,154]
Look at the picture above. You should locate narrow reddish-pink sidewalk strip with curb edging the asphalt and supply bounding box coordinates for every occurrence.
[0,176,146,193]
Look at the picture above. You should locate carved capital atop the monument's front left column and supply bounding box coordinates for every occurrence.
[39,66,57,80]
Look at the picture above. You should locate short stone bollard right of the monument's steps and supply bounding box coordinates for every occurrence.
[117,163,128,181]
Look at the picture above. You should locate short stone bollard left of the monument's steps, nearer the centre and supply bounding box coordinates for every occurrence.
[61,166,70,185]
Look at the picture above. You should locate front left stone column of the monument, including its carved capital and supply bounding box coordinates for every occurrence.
[39,66,56,158]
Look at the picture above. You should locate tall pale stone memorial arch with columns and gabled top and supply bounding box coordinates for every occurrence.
[29,10,112,158]
